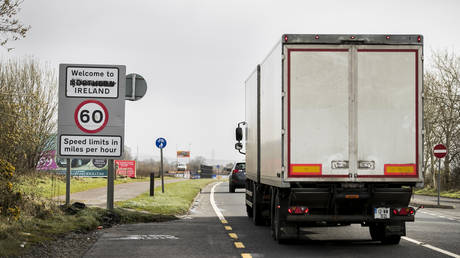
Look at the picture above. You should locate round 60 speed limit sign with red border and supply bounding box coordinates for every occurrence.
[74,100,109,133]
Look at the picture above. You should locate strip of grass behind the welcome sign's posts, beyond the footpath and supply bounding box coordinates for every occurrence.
[18,174,175,198]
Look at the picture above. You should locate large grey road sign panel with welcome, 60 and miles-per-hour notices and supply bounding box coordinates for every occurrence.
[57,64,126,158]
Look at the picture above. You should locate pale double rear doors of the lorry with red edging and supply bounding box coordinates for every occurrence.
[284,44,422,181]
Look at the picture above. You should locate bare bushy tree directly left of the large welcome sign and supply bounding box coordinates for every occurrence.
[0,59,57,173]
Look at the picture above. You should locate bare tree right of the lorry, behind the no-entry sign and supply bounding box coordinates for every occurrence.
[424,51,460,187]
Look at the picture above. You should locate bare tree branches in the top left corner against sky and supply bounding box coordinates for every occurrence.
[0,0,30,51]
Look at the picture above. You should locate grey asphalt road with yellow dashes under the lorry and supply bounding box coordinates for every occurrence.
[85,183,460,258]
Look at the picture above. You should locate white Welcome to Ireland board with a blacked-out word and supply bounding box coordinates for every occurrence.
[66,66,120,98]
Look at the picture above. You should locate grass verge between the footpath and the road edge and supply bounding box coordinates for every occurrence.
[115,179,216,215]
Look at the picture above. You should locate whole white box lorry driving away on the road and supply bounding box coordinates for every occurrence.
[235,34,423,244]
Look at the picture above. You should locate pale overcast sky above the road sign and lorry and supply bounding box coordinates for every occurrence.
[0,0,460,162]
